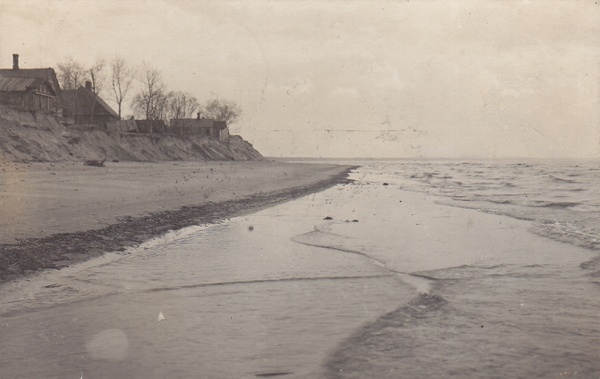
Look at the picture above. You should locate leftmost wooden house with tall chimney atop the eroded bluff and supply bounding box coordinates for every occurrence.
[0,54,62,116]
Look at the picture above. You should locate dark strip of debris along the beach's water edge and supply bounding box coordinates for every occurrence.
[0,164,356,285]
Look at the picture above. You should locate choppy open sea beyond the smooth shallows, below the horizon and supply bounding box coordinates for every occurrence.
[372,160,600,254]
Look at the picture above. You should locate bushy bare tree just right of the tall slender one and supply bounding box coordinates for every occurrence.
[133,63,167,133]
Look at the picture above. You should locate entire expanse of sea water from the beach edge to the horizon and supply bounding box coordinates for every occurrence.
[0,160,600,378]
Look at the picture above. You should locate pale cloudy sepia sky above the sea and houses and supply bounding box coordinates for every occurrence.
[0,0,600,158]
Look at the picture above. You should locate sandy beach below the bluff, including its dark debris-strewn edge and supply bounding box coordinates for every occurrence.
[0,161,348,282]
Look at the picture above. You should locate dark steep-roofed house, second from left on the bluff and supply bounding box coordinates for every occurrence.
[62,81,119,127]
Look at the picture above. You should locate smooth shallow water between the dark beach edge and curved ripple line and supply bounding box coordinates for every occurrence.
[0,183,413,378]
